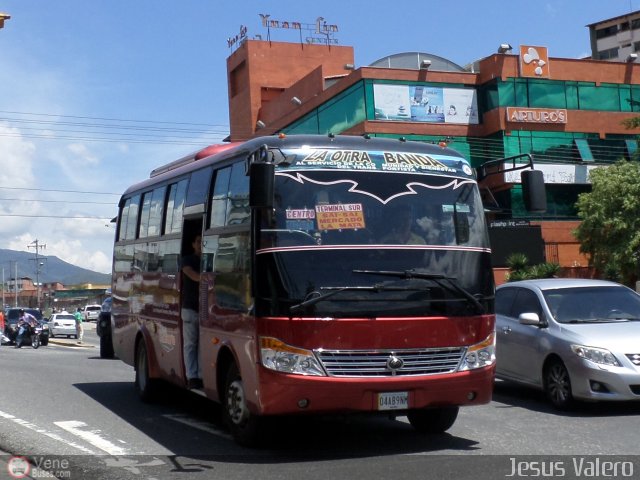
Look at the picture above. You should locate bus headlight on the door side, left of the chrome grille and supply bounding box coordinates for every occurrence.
[260,337,325,377]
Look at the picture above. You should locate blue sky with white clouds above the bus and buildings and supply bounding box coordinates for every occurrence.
[0,0,640,273]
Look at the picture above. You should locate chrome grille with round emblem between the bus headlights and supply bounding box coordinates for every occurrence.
[316,347,465,377]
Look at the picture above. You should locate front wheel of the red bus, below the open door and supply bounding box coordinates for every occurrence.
[222,363,262,447]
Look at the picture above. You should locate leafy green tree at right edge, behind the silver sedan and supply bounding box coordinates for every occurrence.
[574,160,640,286]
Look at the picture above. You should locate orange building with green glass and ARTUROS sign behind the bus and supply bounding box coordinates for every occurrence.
[227,12,640,282]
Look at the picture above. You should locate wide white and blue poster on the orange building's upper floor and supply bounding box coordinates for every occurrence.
[373,84,479,124]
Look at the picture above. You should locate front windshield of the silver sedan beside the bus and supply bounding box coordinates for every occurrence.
[543,286,640,323]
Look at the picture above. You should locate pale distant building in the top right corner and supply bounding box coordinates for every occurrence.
[587,10,640,62]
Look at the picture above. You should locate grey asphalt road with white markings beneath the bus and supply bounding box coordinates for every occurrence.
[0,324,640,480]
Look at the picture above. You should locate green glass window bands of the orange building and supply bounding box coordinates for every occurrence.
[283,78,640,220]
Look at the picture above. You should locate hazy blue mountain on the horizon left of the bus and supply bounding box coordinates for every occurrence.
[0,248,111,286]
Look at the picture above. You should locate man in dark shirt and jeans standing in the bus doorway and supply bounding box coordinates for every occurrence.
[181,235,203,389]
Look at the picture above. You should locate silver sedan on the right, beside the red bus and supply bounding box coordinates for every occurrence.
[496,279,640,408]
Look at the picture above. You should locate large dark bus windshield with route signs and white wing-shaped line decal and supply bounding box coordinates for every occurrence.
[256,169,492,316]
